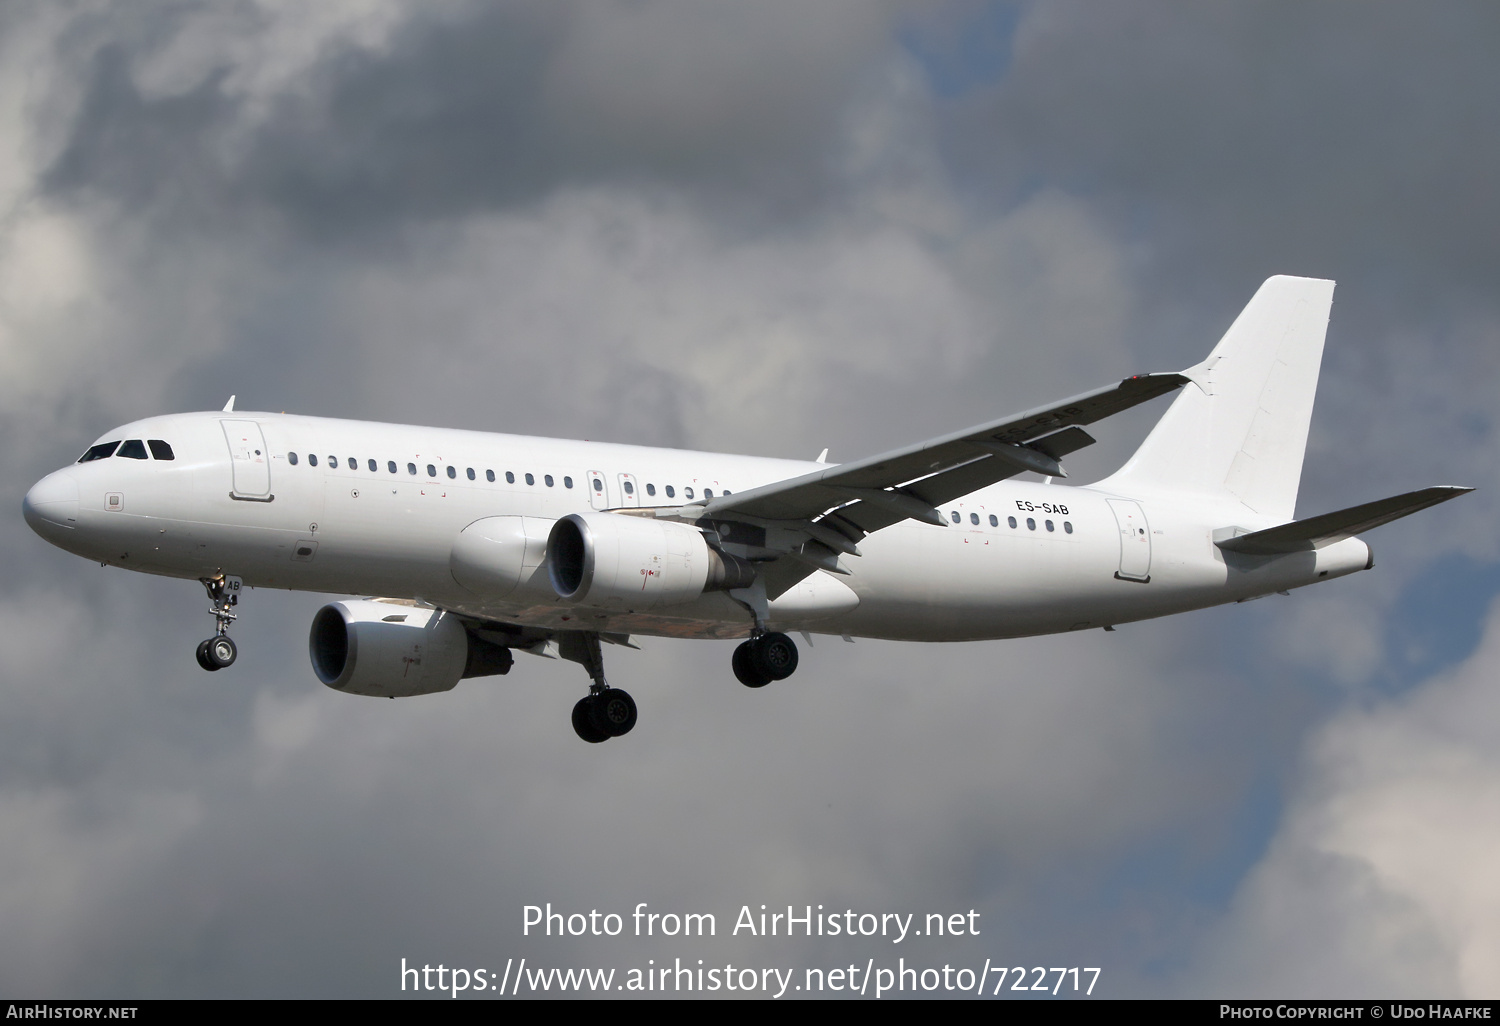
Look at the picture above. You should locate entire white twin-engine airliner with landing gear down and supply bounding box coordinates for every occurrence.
[24,278,1472,741]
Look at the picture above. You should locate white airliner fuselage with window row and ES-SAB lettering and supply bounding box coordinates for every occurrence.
[26,413,1370,641]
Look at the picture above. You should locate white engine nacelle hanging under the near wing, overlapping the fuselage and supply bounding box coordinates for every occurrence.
[548,513,755,611]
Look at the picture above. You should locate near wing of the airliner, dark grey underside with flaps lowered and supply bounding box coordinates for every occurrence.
[704,374,1188,537]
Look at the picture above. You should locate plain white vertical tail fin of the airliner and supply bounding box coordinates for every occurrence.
[1100,276,1334,521]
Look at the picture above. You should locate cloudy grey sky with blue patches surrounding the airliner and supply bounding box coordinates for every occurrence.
[0,0,1500,998]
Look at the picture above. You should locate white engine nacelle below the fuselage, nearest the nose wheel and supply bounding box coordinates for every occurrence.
[308,600,512,698]
